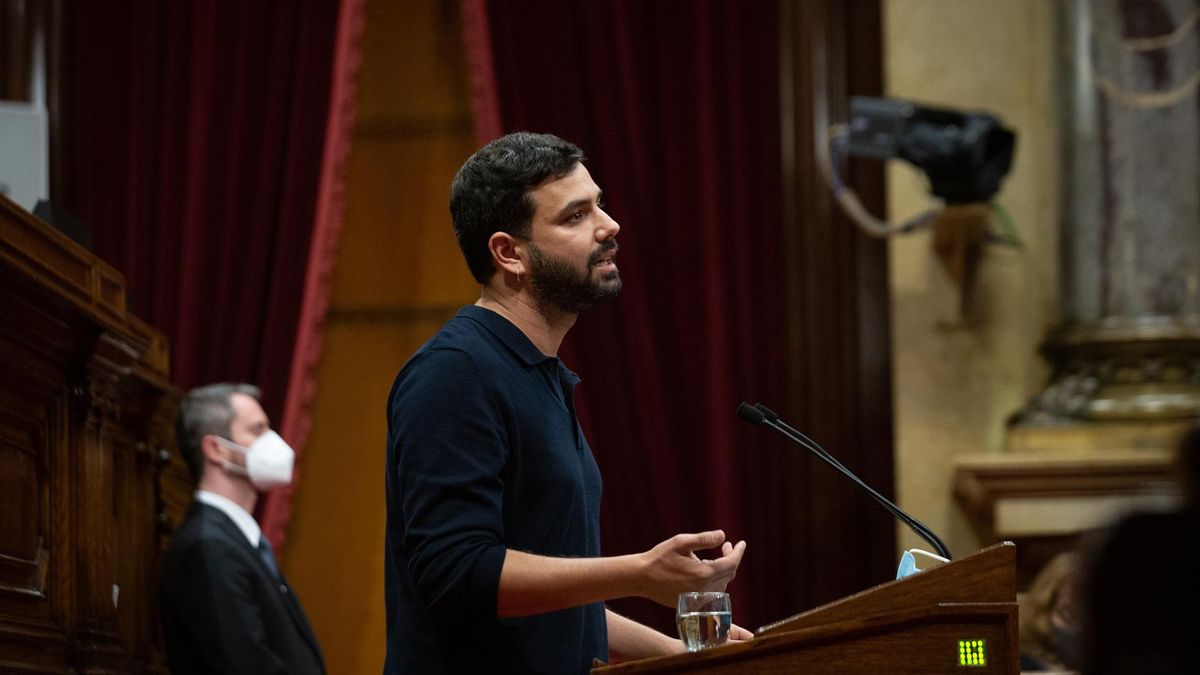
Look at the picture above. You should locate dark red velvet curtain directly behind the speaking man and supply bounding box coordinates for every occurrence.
[463,0,800,633]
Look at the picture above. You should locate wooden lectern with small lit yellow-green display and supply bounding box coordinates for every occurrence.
[592,542,1020,675]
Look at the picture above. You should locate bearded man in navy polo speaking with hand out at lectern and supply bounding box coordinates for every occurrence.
[384,133,749,673]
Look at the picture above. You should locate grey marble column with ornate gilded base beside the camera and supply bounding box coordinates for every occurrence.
[1018,0,1200,426]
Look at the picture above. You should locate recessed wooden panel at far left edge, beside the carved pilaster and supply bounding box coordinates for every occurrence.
[0,277,73,671]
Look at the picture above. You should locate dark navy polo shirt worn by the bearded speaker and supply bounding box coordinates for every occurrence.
[384,306,608,673]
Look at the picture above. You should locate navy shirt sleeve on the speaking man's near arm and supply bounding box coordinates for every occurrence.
[388,350,508,619]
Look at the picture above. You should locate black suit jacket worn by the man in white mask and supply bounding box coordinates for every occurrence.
[160,502,325,675]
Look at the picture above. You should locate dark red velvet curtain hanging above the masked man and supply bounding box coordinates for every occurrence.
[55,0,361,545]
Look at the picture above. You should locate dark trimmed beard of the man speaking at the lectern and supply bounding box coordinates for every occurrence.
[529,239,620,315]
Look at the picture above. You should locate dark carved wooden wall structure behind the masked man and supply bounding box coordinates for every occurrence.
[0,192,177,673]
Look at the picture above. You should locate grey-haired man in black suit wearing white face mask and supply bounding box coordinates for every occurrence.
[160,384,325,675]
